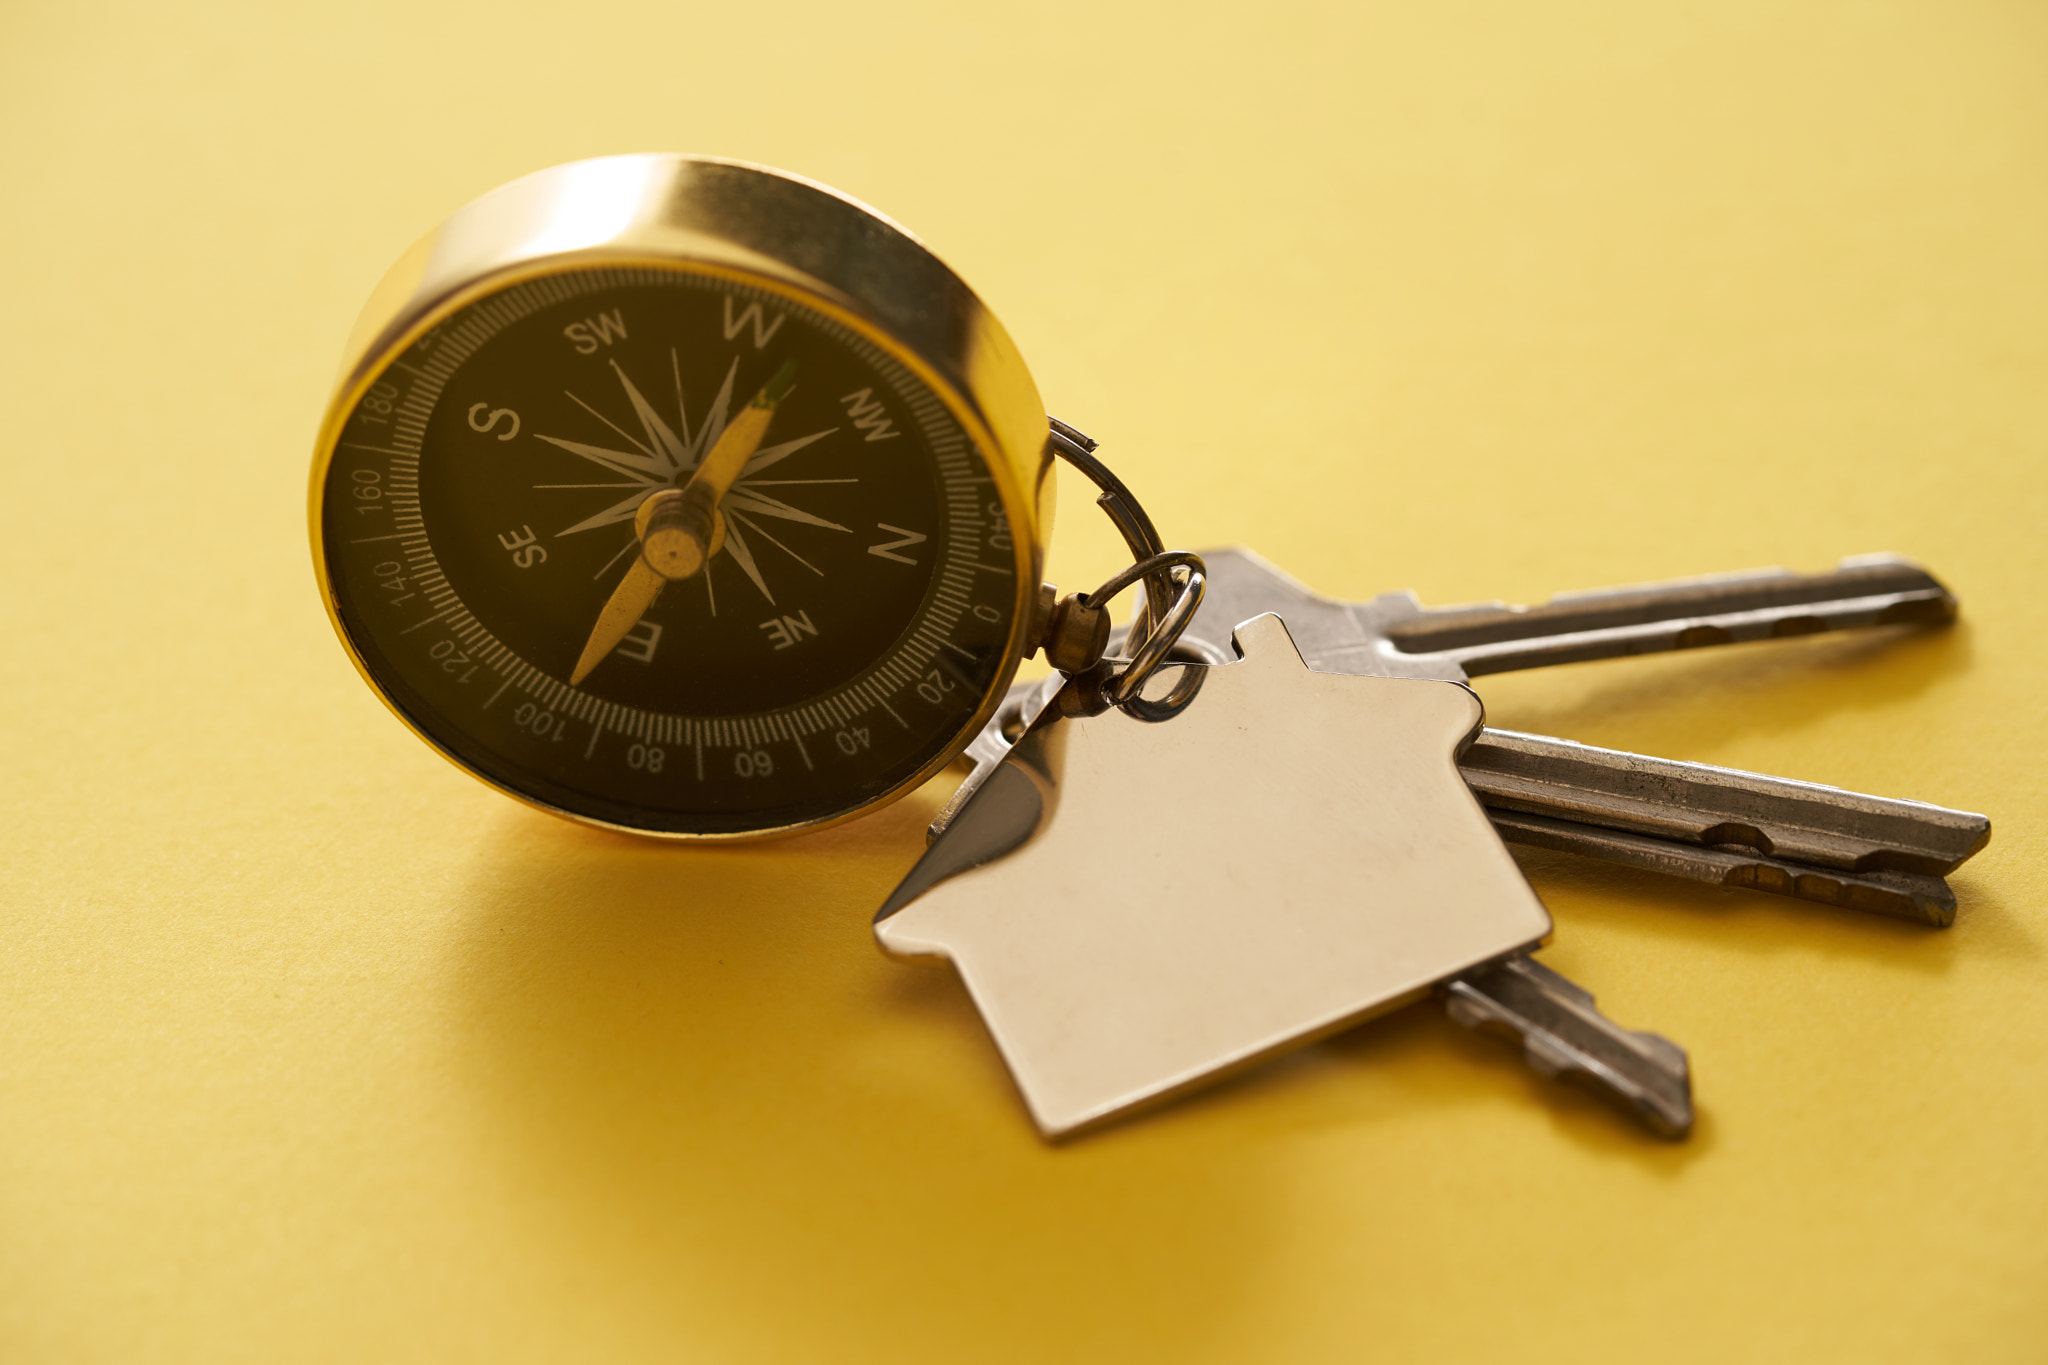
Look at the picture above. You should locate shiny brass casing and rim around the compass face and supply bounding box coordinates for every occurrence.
[309,153,1053,841]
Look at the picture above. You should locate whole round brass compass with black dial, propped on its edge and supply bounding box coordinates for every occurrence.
[311,156,1053,839]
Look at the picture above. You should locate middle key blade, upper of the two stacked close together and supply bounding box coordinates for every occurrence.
[1458,729,1991,875]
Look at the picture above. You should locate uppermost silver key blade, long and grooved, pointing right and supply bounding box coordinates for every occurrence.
[1360,555,1956,677]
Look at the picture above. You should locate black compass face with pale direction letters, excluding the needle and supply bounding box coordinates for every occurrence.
[319,268,1022,835]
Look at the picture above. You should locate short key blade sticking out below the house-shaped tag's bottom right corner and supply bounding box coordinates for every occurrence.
[1440,954,1692,1138]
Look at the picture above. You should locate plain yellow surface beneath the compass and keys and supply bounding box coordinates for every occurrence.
[0,0,2048,1361]
